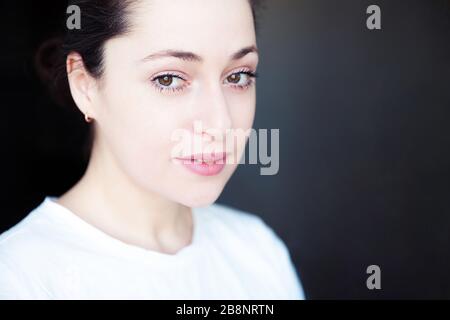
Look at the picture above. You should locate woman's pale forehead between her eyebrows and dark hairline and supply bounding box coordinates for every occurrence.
[120,0,256,56]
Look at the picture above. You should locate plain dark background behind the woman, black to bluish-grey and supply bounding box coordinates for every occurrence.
[0,0,450,299]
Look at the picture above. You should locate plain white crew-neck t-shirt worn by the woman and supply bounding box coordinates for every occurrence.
[0,196,304,300]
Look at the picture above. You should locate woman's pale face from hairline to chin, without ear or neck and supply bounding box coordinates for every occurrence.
[90,0,258,207]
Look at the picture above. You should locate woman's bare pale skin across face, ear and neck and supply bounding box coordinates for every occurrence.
[57,0,258,254]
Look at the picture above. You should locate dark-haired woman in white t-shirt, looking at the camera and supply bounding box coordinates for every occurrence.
[0,0,304,299]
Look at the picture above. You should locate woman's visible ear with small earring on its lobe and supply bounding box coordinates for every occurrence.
[66,52,96,118]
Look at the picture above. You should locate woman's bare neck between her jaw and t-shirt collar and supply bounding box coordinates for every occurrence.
[58,134,192,253]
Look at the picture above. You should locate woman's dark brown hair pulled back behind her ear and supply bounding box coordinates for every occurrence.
[35,0,264,157]
